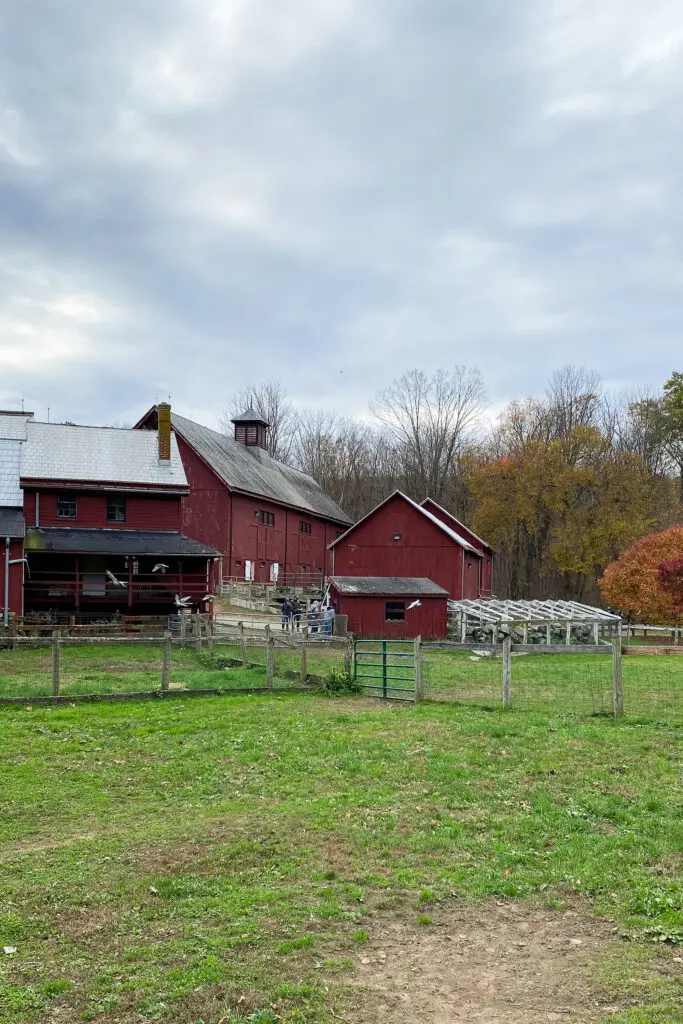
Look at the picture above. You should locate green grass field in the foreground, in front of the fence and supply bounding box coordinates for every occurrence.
[0,688,683,1024]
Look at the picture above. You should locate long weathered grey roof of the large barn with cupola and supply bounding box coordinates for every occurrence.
[171,413,351,525]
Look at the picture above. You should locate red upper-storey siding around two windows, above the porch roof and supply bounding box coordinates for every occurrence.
[24,489,181,531]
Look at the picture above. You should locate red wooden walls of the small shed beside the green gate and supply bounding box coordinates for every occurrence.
[332,585,447,640]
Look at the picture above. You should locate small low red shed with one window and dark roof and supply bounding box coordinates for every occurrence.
[330,577,449,640]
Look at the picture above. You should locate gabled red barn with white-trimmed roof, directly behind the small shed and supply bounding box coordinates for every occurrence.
[330,490,491,600]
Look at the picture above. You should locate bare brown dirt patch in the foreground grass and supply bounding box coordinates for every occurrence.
[344,903,617,1024]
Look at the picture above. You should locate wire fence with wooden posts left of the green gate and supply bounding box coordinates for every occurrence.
[0,633,350,703]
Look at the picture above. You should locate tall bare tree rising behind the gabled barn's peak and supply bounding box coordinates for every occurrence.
[371,366,485,501]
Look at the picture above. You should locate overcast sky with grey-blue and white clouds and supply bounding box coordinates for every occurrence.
[0,0,683,425]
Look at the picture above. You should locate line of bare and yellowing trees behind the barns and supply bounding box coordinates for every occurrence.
[223,366,683,601]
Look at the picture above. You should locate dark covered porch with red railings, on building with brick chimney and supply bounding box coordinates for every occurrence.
[24,527,217,614]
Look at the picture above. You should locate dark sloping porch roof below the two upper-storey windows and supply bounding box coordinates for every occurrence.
[25,526,218,558]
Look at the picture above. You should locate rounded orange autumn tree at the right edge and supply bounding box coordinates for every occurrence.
[599,526,683,626]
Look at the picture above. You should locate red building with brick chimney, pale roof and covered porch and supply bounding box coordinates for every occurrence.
[0,409,218,623]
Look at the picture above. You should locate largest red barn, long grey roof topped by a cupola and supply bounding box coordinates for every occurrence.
[136,407,351,583]
